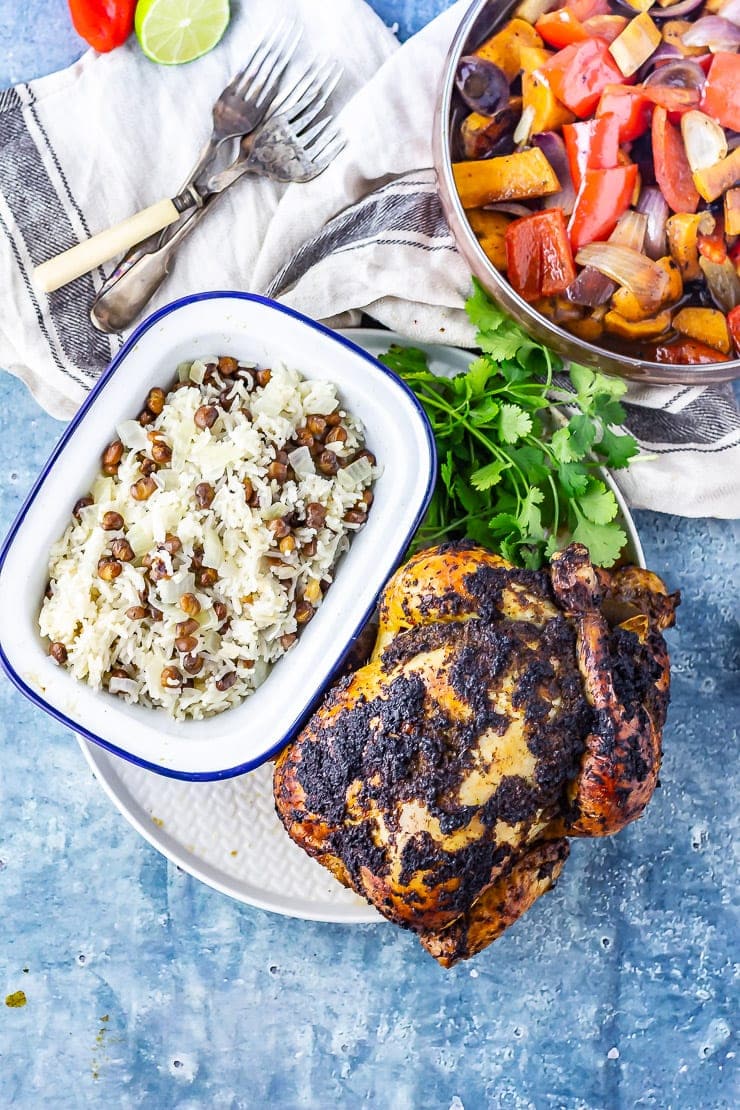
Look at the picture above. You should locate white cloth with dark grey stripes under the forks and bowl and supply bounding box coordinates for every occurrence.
[0,0,740,517]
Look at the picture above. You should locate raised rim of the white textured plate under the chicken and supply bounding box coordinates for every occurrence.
[75,327,646,925]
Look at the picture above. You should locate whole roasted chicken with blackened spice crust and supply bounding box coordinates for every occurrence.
[274,543,679,967]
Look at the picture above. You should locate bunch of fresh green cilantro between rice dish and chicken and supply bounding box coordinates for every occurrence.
[381,282,638,569]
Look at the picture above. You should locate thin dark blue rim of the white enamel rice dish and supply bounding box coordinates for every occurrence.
[0,290,437,783]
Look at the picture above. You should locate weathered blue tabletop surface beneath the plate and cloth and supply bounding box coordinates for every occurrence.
[0,0,740,1110]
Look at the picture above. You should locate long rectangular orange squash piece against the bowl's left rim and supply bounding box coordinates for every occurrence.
[453,147,560,209]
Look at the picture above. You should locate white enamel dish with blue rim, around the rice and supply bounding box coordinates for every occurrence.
[0,293,436,779]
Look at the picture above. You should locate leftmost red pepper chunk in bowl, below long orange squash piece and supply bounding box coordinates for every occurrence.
[505,209,576,301]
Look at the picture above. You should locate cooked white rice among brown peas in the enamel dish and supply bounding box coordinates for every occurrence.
[39,359,378,719]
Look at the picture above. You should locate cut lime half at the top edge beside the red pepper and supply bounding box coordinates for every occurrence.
[134,0,230,65]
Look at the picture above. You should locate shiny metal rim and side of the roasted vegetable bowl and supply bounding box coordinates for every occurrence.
[433,0,740,385]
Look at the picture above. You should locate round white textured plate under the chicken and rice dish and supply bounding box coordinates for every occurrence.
[80,329,645,925]
